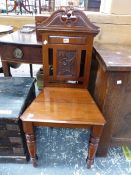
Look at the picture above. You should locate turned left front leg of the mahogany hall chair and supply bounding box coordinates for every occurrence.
[23,122,37,167]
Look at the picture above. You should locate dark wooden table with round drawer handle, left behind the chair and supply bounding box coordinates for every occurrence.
[0,31,42,76]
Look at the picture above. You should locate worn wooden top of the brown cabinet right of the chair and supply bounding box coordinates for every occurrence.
[94,43,131,71]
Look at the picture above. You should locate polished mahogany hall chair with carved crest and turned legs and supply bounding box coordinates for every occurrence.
[21,10,105,168]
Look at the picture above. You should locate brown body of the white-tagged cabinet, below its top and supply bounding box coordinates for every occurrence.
[90,51,131,156]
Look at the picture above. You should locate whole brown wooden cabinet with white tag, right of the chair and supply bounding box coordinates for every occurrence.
[90,43,131,156]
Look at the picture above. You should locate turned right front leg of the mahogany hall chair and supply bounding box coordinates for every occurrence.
[87,126,103,168]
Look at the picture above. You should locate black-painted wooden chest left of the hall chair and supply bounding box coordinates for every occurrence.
[0,77,35,162]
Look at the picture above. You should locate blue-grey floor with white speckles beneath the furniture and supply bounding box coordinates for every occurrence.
[0,64,131,175]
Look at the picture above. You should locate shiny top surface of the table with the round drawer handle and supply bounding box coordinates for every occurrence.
[0,30,42,47]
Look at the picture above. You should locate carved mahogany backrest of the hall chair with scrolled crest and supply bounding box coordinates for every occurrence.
[37,10,99,88]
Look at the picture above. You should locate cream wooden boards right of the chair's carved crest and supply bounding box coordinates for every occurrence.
[88,13,131,44]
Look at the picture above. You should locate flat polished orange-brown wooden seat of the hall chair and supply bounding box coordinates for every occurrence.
[21,87,105,127]
